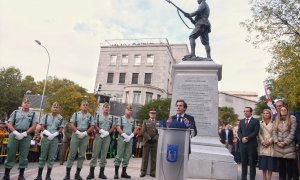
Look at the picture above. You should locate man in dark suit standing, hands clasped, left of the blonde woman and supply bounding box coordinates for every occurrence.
[238,107,260,180]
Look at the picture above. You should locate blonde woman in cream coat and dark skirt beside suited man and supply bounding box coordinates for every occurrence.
[258,109,277,180]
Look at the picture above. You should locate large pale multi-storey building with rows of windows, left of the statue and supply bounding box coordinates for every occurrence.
[95,39,188,105]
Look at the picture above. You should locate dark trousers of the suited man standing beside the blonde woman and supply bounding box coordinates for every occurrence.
[240,143,257,180]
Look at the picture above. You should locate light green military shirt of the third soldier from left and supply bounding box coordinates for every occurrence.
[70,111,95,131]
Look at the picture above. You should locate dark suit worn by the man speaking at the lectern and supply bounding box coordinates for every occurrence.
[169,114,197,154]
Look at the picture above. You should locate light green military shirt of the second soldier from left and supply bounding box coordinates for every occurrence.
[40,113,64,133]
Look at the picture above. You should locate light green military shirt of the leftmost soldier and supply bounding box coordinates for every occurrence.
[8,108,38,130]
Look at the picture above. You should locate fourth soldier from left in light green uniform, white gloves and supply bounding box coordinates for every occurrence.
[86,103,115,179]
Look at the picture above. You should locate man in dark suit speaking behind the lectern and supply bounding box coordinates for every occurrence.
[167,99,197,153]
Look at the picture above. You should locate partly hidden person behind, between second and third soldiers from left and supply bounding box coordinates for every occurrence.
[59,112,72,165]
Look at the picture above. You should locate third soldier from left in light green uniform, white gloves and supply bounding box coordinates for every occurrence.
[64,100,95,180]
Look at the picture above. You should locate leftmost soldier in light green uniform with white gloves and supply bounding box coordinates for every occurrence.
[2,98,37,180]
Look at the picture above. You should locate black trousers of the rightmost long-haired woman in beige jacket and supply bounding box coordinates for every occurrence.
[278,158,295,180]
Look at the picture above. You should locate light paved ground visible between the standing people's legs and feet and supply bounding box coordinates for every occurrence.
[0,158,278,180]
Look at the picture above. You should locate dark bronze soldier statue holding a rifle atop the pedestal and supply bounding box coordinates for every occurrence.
[166,0,211,61]
